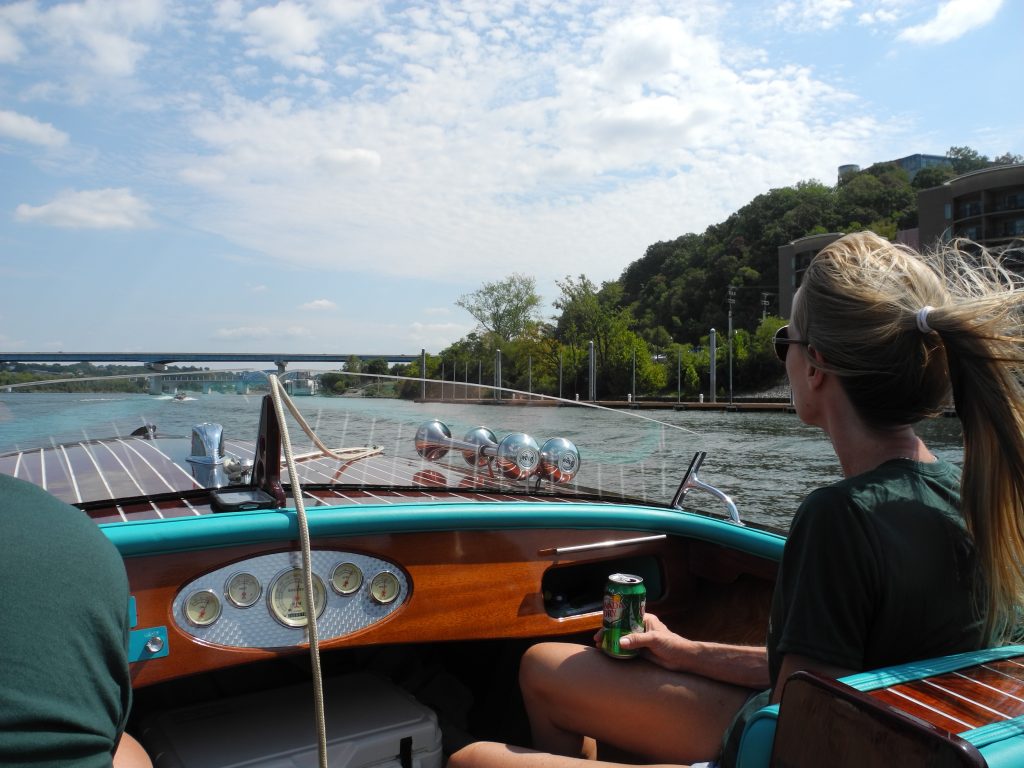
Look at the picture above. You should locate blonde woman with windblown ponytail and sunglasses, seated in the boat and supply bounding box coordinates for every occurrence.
[450,232,1024,768]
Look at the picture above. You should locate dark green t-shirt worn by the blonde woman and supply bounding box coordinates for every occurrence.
[767,459,983,686]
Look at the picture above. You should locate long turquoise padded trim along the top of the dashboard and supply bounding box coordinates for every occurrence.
[100,502,785,561]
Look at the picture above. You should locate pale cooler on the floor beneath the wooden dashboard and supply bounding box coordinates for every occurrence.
[139,673,441,768]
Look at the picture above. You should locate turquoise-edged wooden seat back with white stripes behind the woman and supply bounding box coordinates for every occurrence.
[736,645,1024,768]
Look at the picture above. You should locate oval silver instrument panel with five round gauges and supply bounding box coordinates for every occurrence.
[171,550,411,648]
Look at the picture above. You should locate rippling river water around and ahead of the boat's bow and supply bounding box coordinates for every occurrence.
[0,392,963,528]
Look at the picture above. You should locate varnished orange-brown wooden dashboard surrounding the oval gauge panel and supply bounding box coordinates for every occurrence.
[126,529,688,687]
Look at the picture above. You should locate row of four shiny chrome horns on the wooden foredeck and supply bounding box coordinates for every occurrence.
[416,420,580,482]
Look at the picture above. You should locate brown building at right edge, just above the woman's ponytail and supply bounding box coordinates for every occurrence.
[918,164,1024,249]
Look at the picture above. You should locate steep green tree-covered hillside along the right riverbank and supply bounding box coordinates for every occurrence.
[412,146,1024,398]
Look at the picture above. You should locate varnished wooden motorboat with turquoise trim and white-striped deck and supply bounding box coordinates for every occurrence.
[0,376,1024,768]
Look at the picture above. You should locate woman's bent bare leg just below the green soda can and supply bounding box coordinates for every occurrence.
[519,643,752,764]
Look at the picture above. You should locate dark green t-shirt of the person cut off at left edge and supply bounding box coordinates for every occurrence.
[0,474,131,768]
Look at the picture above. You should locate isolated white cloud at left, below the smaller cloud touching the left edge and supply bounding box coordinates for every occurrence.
[14,188,152,229]
